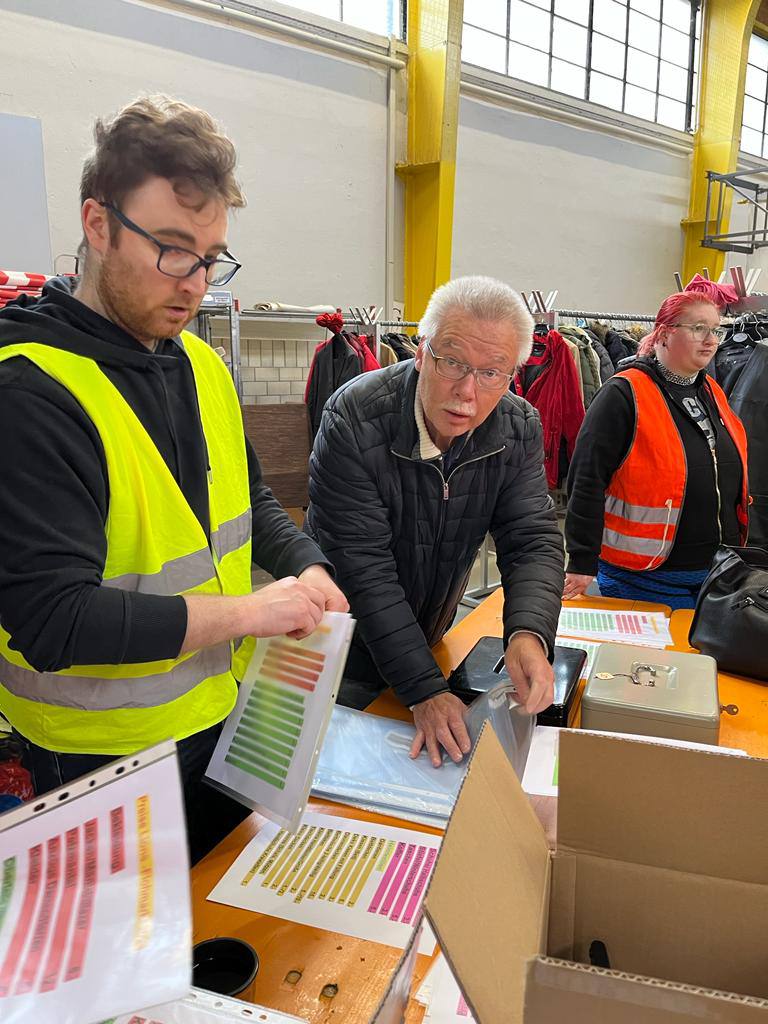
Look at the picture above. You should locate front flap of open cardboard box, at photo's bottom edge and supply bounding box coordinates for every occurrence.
[524,957,768,1024]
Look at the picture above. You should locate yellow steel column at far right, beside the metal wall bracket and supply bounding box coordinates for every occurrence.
[683,0,760,283]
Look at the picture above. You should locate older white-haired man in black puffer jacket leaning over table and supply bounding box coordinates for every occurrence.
[305,276,563,766]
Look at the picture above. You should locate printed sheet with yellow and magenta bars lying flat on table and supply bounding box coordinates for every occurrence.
[208,813,440,953]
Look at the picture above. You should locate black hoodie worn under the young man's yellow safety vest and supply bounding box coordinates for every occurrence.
[0,279,328,672]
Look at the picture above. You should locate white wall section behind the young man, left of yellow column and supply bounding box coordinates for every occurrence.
[0,0,387,306]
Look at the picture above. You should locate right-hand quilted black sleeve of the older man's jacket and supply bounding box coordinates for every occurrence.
[490,403,565,652]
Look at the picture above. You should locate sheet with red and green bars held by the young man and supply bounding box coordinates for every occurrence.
[206,611,354,829]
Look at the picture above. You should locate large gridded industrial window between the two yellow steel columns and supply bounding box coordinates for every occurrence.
[462,0,704,131]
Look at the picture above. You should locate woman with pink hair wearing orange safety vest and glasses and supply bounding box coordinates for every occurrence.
[563,292,749,608]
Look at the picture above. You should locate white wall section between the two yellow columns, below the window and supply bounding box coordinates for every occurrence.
[453,96,689,313]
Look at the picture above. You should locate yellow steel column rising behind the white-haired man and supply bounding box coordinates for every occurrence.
[397,0,464,319]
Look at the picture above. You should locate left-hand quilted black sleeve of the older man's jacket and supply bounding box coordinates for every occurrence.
[309,403,447,707]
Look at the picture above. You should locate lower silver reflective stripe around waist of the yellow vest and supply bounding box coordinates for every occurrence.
[0,643,230,711]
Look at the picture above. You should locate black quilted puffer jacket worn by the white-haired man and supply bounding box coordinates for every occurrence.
[305,360,564,706]
